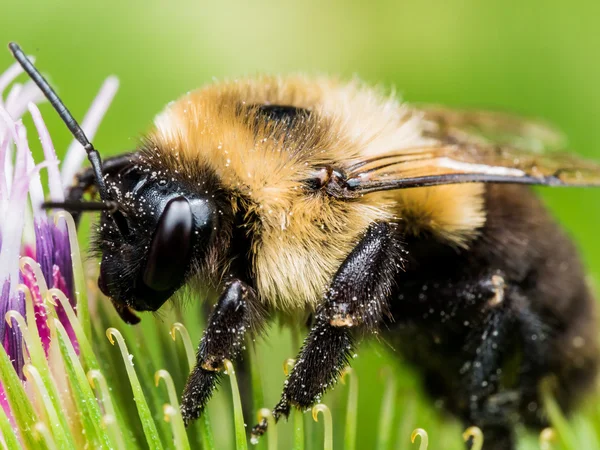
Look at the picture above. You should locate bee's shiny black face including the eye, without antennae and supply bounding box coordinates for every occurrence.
[96,160,218,311]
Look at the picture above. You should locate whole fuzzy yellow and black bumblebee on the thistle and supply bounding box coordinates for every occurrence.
[10,44,600,450]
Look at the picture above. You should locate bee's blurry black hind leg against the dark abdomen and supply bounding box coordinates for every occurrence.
[464,275,547,450]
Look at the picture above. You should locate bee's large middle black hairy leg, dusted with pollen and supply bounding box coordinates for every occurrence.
[253,223,402,435]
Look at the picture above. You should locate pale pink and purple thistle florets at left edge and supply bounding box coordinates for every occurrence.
[0,58,118,374]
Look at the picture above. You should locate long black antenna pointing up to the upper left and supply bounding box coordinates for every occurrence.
[8,42,110,202]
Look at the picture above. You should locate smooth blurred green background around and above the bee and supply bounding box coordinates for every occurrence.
[0,0,600,448]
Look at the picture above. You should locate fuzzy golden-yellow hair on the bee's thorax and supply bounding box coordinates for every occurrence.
[149,77,485,310]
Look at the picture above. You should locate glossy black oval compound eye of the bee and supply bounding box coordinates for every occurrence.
[140,197,194,292]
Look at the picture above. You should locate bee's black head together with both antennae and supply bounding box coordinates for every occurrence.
[9,42,226,323]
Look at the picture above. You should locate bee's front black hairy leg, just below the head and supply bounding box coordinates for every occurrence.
[181,279,260,425]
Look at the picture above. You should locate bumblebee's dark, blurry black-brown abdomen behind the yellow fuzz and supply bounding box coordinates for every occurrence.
[388,185,598,432]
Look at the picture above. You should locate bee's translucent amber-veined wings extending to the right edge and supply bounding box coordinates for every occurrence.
[346,108,600,196]
